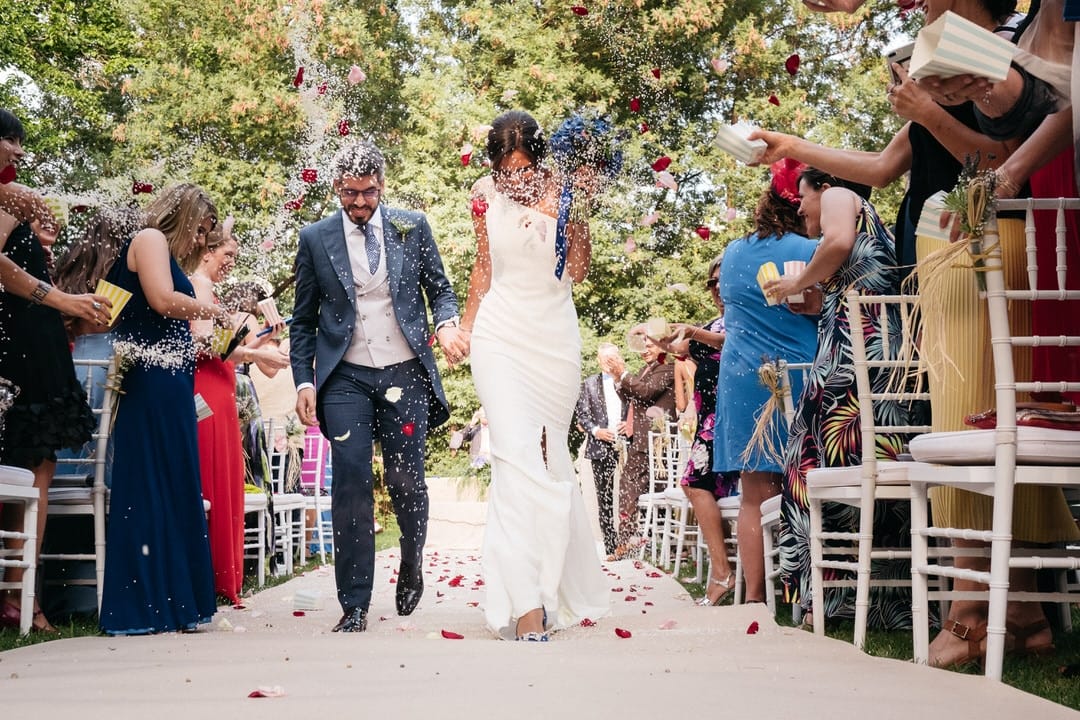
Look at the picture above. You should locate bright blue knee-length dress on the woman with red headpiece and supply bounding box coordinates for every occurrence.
[713,233,818,473]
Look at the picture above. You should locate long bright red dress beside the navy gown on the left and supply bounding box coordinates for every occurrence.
[195,357,244,602]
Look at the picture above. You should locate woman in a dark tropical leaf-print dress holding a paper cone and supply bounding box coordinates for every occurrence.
[764,167,917,628]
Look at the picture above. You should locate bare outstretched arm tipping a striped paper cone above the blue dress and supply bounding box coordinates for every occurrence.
[747,125,912,188]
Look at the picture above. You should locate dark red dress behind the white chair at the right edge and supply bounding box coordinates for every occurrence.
[1031,148,1080,402]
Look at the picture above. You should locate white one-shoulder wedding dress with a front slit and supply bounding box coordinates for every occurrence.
[471,178,610,637]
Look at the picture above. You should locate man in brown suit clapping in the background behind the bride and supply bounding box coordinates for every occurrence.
[600,331,675,560]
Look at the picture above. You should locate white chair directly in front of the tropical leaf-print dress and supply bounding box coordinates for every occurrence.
[807,290,931,649]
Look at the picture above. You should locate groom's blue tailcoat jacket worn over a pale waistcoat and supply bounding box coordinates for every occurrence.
[289,205,458,427]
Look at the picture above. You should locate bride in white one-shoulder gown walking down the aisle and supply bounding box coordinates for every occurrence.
[461,110,610,641]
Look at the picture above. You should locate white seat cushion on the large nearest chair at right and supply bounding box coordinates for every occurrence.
[910,425,1080,465]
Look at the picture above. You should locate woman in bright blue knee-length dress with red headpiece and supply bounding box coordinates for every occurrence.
[713,170,818,602]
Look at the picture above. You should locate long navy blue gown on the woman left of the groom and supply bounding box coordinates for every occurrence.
[100,243,215,635]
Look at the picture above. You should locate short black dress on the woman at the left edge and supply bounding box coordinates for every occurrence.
[0,223,95,468]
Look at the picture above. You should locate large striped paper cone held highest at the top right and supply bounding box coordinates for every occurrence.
[909,11,1016,82]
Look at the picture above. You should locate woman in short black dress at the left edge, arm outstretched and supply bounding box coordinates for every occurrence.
[0,109,109,633]
